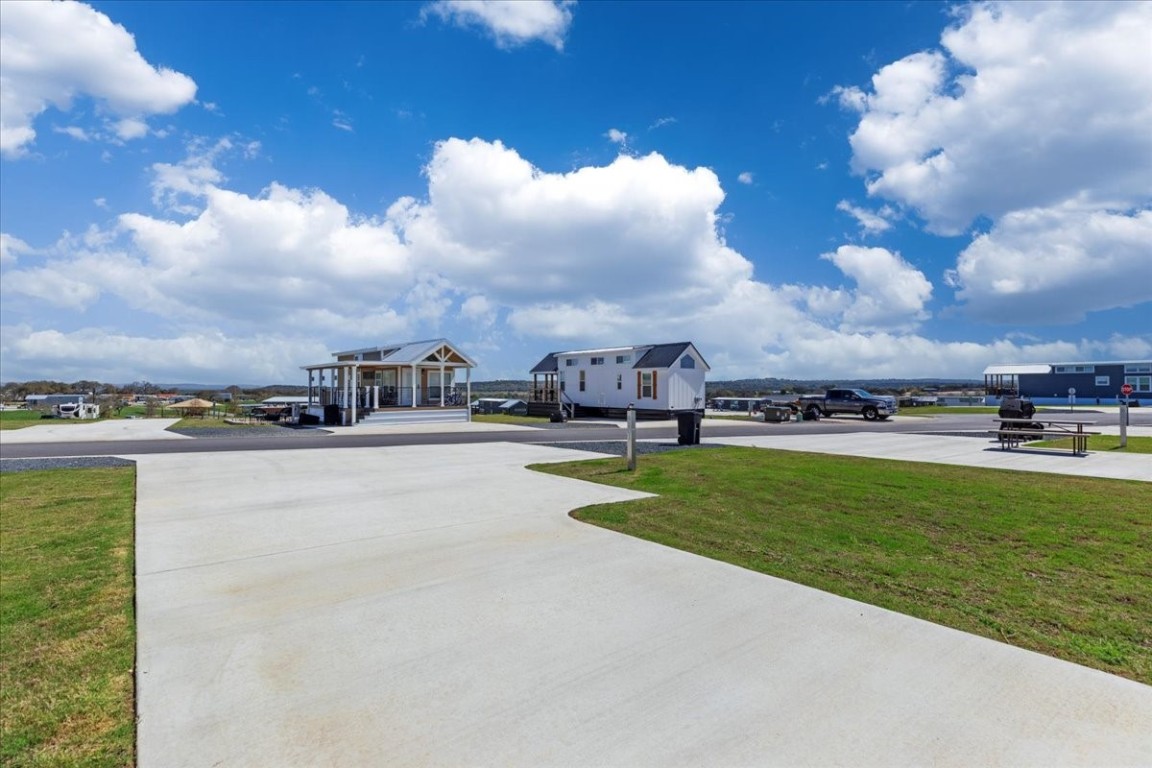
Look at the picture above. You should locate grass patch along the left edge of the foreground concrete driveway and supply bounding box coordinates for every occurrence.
[0,467,136,768]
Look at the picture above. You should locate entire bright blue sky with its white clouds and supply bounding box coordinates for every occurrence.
[0,0,1152,385]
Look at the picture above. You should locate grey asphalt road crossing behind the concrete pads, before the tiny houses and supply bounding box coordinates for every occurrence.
[0,409,1152,458]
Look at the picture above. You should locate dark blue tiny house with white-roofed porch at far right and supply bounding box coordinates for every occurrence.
[984,360,1152,404]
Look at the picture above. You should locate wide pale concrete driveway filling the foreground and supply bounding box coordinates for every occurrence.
[136,443,1152,768]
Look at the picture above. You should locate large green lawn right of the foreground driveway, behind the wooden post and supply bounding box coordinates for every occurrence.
[535,448,1152,683]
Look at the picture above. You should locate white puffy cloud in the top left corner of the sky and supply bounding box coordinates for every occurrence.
[0,0,196,157]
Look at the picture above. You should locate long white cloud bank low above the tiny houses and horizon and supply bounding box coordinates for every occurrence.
[0,132,1147,383]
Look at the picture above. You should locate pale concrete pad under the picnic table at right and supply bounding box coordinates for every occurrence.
[702,432,1152,481]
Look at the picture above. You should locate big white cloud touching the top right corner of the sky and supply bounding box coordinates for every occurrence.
[836,2,1152,234]
